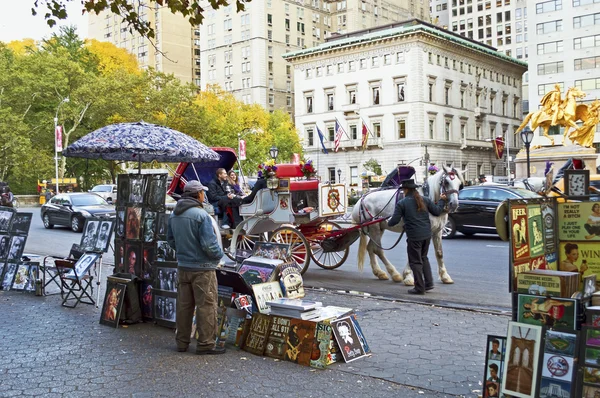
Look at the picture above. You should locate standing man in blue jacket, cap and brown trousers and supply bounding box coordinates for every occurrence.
[167,181,225,355]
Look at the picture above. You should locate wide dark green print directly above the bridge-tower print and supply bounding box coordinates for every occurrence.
[517,294,577,330]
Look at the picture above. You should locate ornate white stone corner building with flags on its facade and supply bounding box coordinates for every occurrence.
[284,20,527,184]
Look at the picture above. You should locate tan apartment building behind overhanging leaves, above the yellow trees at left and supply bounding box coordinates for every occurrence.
[88,1,193,84]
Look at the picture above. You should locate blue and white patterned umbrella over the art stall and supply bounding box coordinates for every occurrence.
[63,122,220,163]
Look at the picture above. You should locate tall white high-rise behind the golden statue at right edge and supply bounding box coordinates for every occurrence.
[529,0,600,147]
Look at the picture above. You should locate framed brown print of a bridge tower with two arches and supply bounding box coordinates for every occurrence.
[502,322,542,398]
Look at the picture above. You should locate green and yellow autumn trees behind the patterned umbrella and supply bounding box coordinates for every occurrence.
[0,28,301,193]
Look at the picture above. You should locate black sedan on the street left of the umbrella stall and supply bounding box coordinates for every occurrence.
[40,192,116,232]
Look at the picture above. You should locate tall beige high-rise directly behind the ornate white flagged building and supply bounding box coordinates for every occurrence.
[194,0,429,114]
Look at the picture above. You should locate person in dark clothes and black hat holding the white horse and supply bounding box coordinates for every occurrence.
[388,179,446,294]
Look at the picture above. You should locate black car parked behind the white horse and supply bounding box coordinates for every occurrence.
[442,185,541,238]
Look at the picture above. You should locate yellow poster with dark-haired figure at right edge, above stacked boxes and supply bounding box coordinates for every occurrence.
[558,242,600,287]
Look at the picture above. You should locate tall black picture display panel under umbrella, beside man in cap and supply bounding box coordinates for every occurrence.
[115,173,168,326]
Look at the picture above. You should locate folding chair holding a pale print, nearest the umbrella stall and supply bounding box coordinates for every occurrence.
[59,260,96,308]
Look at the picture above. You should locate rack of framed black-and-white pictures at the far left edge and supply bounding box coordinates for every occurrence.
[0,207,34,292]
